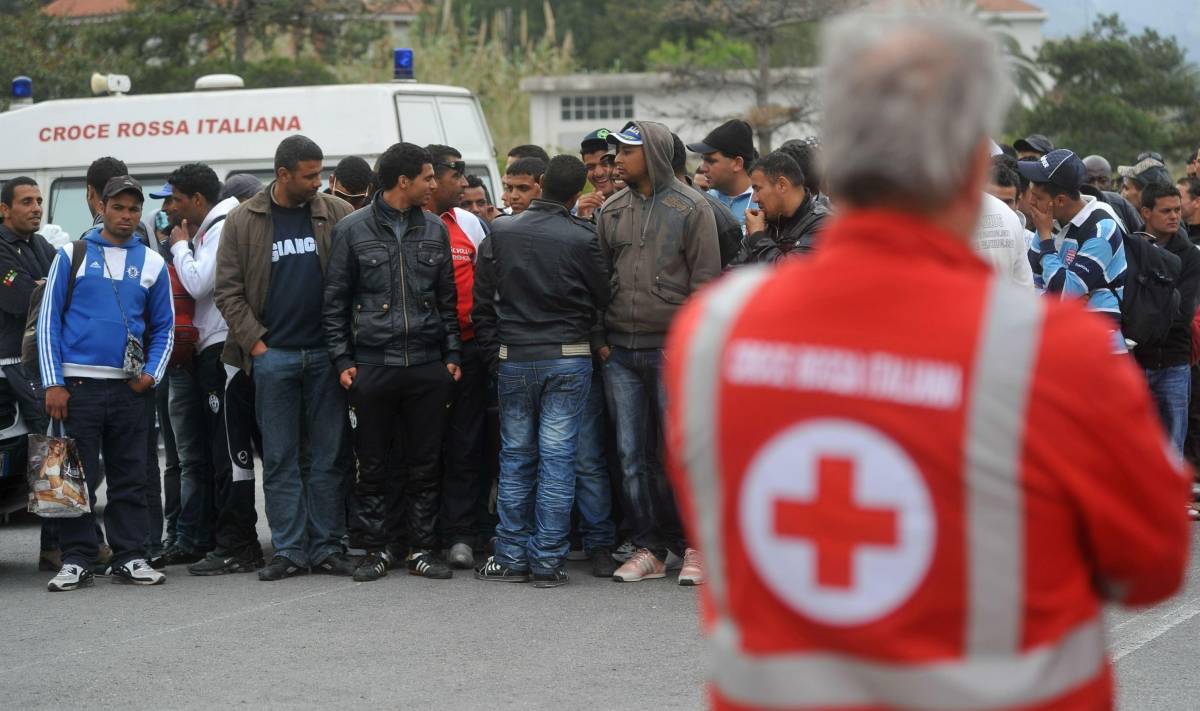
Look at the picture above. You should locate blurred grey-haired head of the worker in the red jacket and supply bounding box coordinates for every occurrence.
[821,7,1014,211]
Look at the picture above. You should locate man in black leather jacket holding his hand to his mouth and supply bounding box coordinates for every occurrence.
[746,150,829,263]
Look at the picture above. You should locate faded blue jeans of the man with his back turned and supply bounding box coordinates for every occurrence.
[496,358,592,573]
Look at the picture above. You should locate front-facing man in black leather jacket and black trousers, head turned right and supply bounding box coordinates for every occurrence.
[324,143,461,581]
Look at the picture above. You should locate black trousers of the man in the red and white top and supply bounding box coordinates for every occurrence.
[442,340,492,548]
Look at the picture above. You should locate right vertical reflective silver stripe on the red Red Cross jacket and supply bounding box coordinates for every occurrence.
[964,279,1043,657]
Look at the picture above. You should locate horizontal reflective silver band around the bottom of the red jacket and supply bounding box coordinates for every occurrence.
[706,614,1104,711]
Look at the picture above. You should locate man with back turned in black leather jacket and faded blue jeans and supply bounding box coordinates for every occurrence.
[472,155,610,587]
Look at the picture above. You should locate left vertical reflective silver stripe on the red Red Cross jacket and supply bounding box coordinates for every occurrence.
[672,268,769,613]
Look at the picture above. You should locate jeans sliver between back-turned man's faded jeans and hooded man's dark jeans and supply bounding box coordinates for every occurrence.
[575,370,617,552]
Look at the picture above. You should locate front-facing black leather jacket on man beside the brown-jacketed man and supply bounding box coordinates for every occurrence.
[324,192,462,372]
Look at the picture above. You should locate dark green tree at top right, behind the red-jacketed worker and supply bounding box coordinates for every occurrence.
[1014,14,1200,162]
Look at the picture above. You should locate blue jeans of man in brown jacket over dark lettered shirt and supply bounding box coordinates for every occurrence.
[253,348,346,567]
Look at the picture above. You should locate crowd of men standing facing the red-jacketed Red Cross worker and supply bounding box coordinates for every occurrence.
[0,97,1200,591]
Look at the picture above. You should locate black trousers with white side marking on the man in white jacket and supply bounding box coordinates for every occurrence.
[196,342,262,557]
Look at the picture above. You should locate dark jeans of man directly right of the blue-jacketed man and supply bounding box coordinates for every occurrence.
[167,368,216,552]
